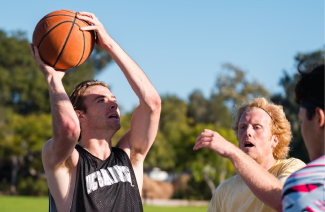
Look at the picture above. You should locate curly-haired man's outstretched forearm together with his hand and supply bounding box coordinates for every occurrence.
[193,129,283,211]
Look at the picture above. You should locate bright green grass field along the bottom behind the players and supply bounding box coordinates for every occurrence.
[0,196,208,212]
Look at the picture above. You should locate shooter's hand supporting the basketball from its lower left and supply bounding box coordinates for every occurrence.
[29,43,65,79]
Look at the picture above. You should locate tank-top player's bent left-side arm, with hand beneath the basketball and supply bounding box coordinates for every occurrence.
[30,44,80,171]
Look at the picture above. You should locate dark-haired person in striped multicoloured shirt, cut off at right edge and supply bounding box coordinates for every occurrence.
[282,65,325,212]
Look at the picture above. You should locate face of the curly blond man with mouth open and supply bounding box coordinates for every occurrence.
[237,108,277,164]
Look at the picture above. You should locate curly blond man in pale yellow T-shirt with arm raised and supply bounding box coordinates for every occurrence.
[194,98,305,212]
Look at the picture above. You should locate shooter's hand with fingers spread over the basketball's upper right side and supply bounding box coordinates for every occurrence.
[77,12,110,48]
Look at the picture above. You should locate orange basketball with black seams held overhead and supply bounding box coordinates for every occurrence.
[33,10,95,70]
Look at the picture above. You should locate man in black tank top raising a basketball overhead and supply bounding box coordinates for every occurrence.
[31,12,161,212]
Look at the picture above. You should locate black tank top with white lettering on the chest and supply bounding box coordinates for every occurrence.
[49,145,143,212]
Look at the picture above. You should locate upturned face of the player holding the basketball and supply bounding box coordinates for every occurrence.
[78,85,121,132]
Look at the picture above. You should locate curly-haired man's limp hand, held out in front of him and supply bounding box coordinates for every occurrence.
[193,129,237,158]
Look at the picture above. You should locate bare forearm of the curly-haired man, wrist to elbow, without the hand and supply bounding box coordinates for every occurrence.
[229,149,283,211]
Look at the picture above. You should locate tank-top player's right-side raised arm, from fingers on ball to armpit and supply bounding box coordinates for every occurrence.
[77,12,161,191]
